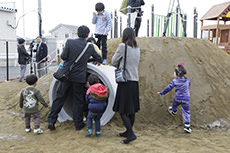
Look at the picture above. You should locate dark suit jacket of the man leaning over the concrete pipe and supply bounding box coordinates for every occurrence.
[61,38,102,83]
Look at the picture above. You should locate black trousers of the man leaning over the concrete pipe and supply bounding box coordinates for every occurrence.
[48,81,85,128]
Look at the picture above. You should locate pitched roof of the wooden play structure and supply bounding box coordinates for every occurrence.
[200,1,230,21]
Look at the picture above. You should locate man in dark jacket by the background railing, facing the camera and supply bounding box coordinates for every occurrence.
[35,36,48,78]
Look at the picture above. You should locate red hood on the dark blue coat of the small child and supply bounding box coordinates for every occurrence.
[86,83,107,97]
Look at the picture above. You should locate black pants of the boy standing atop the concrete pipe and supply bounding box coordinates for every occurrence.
[96,35,107,59]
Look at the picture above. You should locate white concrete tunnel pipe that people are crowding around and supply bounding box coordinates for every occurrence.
[49,63,117,125]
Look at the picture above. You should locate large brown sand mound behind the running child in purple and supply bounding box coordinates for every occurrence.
[108,38,230,127]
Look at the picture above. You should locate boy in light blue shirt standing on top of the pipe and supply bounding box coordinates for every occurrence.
[92,3,112,64]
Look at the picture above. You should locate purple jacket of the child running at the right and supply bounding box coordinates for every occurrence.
[160,77,191,99]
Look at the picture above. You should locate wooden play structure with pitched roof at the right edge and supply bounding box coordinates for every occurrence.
[200,1,230,53]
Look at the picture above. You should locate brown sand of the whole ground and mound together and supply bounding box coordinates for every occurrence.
[0,38,230,153]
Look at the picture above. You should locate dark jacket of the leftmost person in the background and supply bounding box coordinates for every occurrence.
[18,44,30,65]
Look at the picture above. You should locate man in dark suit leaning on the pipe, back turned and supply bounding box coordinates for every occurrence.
[48,26,102,130]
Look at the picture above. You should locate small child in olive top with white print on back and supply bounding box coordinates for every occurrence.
[19,75,48,134]
